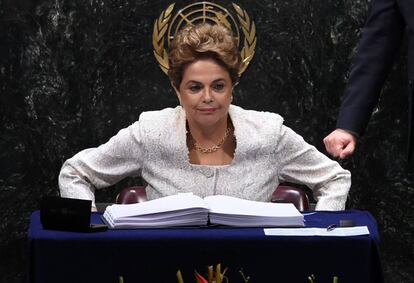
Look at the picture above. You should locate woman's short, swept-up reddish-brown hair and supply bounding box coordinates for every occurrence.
[168,23,241,88]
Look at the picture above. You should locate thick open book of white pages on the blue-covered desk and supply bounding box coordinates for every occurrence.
[103,193,305,229]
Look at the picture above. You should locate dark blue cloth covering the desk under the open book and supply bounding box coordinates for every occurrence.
[29,210,382,283]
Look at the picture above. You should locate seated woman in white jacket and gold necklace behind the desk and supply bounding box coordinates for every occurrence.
[59,24,350,210]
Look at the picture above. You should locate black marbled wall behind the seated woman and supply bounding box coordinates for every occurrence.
[0,0,414,283]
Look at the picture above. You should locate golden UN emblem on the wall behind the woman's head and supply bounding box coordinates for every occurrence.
[152,2,256,76]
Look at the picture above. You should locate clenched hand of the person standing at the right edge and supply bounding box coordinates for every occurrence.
[323,129,357,159]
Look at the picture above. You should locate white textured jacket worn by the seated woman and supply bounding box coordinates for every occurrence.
[59,105,351,210]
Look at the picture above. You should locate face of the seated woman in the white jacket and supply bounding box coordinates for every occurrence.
[175,59,233,127]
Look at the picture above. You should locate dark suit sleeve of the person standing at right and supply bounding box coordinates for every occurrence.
[337,0,404,135]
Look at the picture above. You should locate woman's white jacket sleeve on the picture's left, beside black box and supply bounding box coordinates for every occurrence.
[59,122,145,206]
